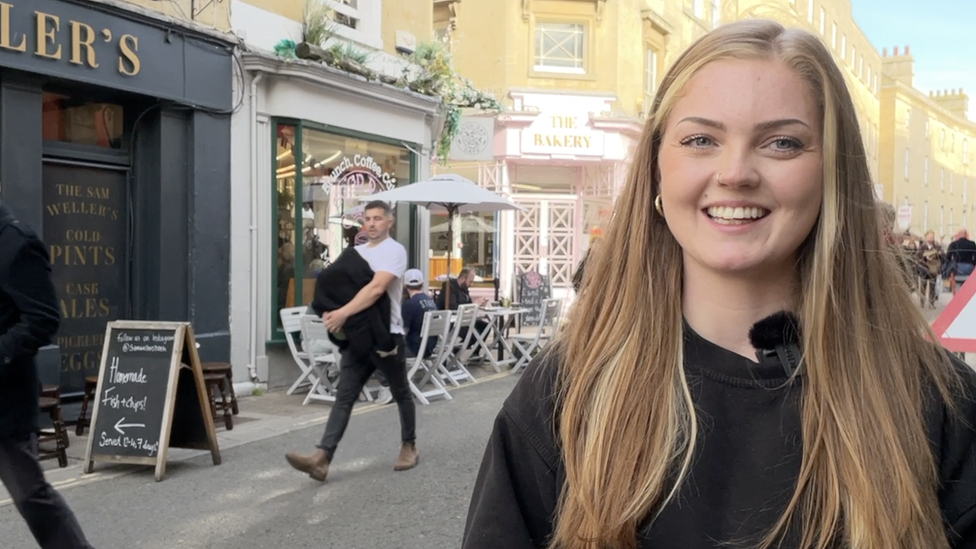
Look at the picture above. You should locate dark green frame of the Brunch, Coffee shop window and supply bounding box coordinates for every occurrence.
[267,116,422,338]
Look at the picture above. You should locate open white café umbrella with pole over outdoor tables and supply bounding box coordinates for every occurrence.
[359,173,521,304]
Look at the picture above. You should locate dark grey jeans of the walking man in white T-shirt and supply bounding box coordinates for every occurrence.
[318,335,417,462]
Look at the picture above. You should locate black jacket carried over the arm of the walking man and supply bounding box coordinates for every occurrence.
[312,248,396,359]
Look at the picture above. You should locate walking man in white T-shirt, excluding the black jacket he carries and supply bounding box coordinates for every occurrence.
[285,201,418,482]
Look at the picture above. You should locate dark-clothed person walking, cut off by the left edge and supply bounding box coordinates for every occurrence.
[0,202,91,549]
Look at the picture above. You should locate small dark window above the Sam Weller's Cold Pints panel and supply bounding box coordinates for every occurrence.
[42,92,125,149]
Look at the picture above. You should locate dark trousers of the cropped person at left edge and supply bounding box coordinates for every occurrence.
[0,436,92,549]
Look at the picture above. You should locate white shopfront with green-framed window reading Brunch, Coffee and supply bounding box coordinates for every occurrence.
[231,52,440,390]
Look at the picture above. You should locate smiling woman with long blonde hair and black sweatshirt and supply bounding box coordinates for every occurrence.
[462,20,976,549]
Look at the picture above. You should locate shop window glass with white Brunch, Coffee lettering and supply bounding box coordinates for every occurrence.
[273,124,414,332]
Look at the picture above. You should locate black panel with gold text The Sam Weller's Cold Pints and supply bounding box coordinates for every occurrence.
[42,158,129,397]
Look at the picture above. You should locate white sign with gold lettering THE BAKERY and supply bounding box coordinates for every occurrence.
[522,112,604,156]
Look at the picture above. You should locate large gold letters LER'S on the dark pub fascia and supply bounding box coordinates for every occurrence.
[0,0,142,76]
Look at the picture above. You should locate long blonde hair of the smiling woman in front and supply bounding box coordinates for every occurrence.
[551,20,957,549]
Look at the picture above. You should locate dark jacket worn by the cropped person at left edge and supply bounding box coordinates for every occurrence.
[0,203,61,439]
